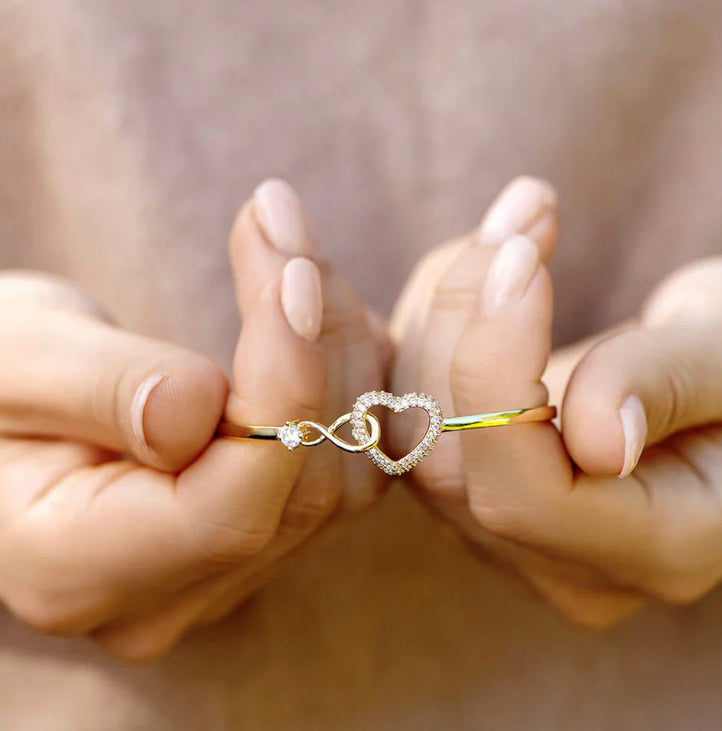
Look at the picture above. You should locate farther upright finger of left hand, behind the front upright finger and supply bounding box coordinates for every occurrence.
[231,179,384,522]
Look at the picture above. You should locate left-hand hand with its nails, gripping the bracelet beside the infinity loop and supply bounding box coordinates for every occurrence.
[0,181,385,660]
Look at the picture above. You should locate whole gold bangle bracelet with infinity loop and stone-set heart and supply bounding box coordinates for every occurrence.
[217,391,557,475]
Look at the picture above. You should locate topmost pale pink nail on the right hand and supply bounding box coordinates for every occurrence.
[479,176,557,246]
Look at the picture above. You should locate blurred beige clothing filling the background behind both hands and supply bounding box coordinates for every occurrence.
[0,0,722,731]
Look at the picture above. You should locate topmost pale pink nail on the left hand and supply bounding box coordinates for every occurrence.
[253,178,311,256]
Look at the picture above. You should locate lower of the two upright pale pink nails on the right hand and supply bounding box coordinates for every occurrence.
[482,236,539,315]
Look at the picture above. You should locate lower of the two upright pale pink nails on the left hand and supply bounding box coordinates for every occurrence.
[281,257,323,343]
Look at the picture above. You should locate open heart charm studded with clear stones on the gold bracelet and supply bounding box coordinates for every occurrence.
[351,391,444,475]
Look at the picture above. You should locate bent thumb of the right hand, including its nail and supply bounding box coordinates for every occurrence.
[563,319,722,476]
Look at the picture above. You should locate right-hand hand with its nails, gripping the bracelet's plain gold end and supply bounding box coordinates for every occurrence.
[392,178,722,626]
